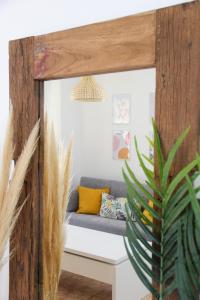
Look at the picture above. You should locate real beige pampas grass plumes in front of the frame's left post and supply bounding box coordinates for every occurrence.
[0,110,39,269]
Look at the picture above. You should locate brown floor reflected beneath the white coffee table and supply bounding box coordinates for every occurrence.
[57,272,112,300]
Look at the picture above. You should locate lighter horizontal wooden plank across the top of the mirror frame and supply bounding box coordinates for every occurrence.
[34,12,155,80]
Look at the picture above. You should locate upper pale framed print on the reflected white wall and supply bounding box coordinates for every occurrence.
[112,94,131,124]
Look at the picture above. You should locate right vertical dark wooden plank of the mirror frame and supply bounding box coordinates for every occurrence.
[155,2,200,176]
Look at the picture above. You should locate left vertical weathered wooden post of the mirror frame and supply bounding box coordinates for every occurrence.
[9,37,43,300]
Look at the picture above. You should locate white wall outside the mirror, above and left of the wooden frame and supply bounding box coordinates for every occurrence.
[0,0,194,300]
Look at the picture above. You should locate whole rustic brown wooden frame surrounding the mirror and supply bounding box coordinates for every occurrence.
[9,1,200,300]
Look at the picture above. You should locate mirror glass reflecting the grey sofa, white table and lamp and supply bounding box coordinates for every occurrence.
[45,69,155,300]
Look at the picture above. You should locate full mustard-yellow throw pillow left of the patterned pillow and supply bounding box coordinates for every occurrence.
[77,186,110,215]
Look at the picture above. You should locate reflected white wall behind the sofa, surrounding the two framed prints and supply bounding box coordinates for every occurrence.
[81,69,155,180]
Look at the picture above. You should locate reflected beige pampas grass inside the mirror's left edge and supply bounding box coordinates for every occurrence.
[43,117,72,300]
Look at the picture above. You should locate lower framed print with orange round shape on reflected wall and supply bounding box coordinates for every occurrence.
[113,130,131,160]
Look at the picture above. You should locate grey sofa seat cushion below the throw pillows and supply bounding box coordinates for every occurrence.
[67,212,126,235]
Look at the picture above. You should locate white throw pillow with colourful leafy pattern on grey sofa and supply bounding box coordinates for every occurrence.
[100,193,127,220]
